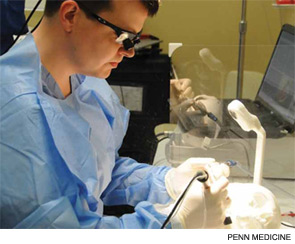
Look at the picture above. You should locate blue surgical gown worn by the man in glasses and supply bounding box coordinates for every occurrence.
[0,34,171,228]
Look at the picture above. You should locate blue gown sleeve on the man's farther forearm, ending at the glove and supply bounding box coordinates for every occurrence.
[102,157,171,206]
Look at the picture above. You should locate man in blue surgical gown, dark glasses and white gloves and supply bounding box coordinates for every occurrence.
[0,0,227,228]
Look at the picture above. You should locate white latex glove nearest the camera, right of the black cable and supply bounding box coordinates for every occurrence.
[176,176,230,229]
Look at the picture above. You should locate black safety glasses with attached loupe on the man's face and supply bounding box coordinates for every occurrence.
[76,1,142,51]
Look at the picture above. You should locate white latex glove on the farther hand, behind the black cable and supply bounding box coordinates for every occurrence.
[165,158,229,200]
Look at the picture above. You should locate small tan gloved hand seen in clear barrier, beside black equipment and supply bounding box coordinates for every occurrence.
[170,78,194,106]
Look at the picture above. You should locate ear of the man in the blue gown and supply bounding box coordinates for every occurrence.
[59,0,81,33]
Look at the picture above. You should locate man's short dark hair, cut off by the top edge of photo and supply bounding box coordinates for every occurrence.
[44,0,159,17]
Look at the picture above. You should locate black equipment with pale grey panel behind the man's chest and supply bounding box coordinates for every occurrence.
[107,50,170,164]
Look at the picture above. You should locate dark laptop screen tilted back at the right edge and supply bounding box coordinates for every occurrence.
[256,30,295,125]
